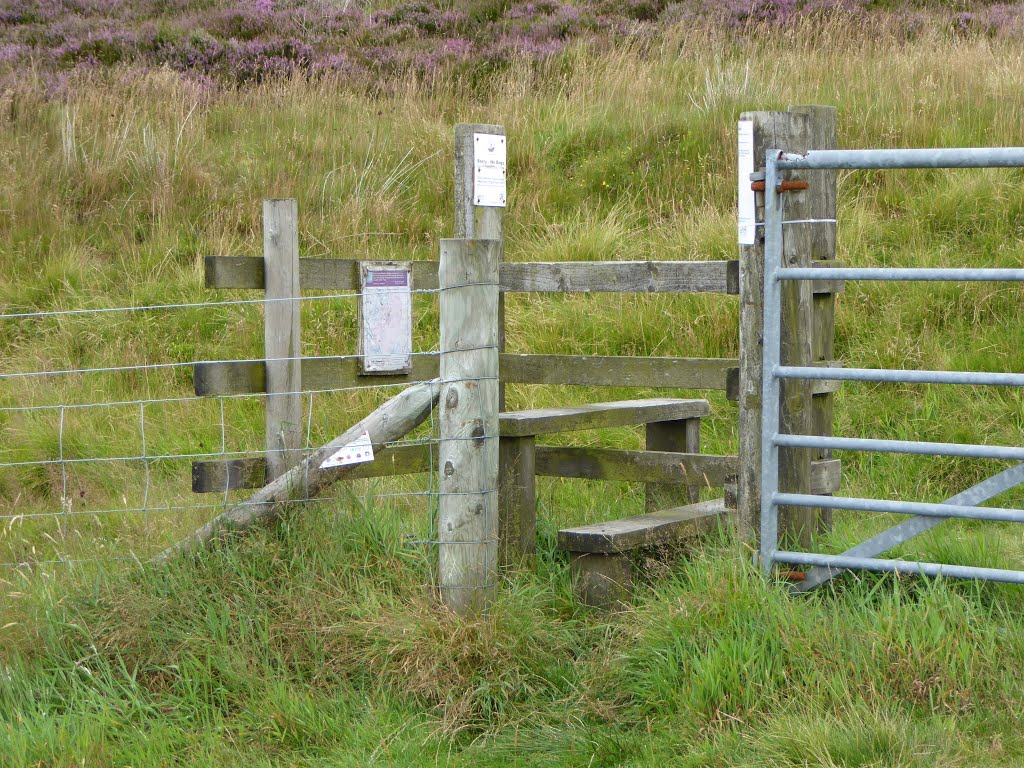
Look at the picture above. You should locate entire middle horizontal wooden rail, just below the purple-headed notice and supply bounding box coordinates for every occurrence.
[194,353,737,396]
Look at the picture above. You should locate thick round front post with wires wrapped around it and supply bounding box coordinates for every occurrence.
[437,240,501,614]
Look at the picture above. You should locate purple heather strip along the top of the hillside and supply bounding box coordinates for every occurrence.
[0,0,1024,89]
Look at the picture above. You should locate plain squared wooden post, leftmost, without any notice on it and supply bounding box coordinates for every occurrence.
[263,200,302,481]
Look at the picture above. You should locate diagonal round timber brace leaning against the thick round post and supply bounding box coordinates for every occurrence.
[156,380,440,562]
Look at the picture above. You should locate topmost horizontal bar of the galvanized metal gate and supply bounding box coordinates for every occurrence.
[769,146,1024,171]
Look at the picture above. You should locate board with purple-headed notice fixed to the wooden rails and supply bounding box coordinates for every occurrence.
[358,261,413,376]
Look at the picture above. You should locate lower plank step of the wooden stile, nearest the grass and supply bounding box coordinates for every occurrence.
[558,499,729,554]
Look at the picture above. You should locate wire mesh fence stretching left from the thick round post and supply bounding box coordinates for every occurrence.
[0,289,448,587]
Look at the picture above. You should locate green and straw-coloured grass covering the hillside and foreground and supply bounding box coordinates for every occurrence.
[0,13,1024,766]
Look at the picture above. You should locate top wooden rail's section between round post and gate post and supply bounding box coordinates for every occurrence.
[501,261,739,294]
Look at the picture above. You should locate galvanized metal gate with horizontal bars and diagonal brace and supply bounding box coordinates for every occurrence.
[761,147,1024,591]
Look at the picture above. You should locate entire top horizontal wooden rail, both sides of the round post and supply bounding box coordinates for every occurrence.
[206,256,739,294]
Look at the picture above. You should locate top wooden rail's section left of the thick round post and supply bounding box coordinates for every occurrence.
[204,256,437,291]
